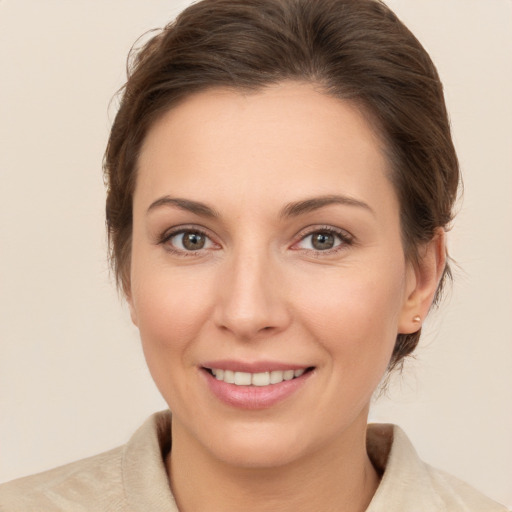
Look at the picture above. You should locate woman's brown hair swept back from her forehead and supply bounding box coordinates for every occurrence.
[104,0,459,368]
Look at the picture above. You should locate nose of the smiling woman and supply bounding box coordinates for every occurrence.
[214,251,290,340]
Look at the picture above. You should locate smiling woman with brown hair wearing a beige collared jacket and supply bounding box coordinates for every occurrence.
[0,0,504,512]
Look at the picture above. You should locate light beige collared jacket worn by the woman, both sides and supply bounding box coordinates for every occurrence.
[0,411,506,512]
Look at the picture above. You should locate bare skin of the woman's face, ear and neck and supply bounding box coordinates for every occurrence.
[128,83,445,512]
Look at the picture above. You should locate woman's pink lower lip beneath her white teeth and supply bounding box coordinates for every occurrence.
[202,369,313,410]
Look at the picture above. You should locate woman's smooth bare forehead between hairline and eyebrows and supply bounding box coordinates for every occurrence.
[135,83,392,212]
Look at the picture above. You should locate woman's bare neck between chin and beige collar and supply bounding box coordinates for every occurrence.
[167,420,379,512]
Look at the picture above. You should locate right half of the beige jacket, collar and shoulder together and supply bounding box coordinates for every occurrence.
[367,424,507,512]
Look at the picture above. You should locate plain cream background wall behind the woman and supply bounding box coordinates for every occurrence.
[0,0,512,506]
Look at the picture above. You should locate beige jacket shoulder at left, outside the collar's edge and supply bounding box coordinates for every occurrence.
[0,447,125,512]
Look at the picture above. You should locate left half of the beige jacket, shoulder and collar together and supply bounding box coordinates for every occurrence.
[0,411,178,512]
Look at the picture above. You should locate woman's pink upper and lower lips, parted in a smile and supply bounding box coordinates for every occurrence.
[202,360,313,410]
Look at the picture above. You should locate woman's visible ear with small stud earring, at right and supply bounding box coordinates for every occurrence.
[398,228,446,334]
